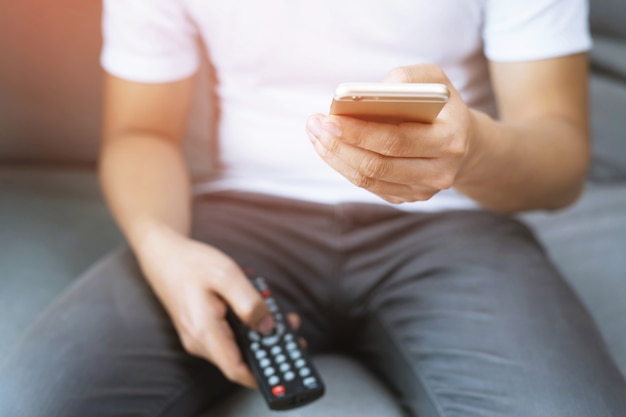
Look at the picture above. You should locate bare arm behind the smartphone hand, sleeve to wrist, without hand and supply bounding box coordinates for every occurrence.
[455,54,589,211]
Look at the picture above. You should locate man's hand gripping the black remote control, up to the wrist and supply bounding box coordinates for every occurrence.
[139,224,274,388]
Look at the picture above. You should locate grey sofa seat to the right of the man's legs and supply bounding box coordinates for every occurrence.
[523,184,626,375]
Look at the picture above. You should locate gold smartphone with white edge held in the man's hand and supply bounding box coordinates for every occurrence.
[330,83,450,123]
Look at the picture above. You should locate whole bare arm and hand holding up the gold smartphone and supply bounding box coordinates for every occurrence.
[307,55,589,212]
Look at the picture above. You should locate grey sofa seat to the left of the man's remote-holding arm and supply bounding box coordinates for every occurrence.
[0,167,122,357]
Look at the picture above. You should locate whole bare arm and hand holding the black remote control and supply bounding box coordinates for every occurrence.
[100,75,273,387]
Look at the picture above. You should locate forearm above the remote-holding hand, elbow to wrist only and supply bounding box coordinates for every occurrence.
[100,133,191,257]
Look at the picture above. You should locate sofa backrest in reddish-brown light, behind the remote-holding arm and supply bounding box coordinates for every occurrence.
[0,0,213,175]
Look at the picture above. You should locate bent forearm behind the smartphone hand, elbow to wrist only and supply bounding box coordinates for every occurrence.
[455,112,589,212]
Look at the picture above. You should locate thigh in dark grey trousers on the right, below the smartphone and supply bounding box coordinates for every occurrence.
[332,211,626,417]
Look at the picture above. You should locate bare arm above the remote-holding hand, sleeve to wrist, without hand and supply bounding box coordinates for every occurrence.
[100,75,194,247]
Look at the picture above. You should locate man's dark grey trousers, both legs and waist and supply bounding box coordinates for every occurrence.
[0,193,626,417]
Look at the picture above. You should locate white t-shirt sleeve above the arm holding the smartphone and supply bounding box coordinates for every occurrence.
[483,0,591,61]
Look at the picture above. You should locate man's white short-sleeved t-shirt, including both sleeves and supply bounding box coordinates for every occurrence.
[101,0,591,211]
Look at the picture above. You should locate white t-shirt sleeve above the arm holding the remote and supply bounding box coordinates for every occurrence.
[100,0,199,83]
